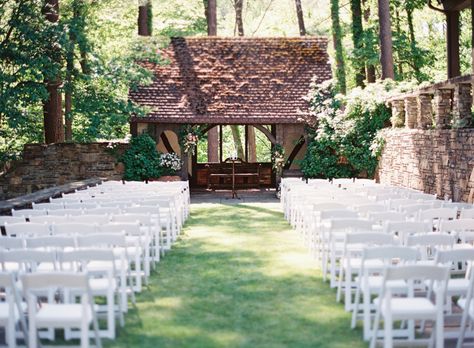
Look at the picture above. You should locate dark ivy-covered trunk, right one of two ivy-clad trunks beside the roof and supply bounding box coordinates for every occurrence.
[351,0,366,87]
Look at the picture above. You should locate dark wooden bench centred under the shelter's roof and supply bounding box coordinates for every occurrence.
[207,160,260,190]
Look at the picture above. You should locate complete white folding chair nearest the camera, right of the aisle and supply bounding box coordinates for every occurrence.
[370,265,449,348]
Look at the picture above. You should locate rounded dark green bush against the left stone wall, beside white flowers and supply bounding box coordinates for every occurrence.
[121,134,163,181]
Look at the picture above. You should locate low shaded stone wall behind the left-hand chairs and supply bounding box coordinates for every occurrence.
[0,143,127,200]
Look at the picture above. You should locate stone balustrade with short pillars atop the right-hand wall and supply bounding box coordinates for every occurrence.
[387,75,474,129]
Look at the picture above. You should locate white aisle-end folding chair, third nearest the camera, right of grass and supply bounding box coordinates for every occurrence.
[336,232,394,311]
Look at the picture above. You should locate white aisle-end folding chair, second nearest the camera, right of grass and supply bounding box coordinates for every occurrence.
[351,245,419,340]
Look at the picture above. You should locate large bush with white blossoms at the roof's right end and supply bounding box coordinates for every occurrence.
[301,80,406,178]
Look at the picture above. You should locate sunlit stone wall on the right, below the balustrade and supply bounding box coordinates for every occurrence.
[378,128,474,202]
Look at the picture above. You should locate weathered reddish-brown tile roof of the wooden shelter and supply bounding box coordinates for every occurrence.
[130,37,331,124]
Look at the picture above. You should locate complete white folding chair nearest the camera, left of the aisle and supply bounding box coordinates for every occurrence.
[21,272,102,348]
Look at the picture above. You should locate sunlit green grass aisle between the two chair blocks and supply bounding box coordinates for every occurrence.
[104,204,366,348]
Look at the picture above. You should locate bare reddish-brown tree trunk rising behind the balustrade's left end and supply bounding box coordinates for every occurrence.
[378,0,395,80]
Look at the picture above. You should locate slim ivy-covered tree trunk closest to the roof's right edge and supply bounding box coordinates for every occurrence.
[331,0,346,94]
